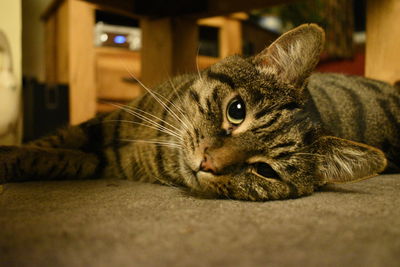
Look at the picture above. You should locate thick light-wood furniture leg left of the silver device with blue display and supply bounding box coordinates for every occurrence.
[42,0,97,124]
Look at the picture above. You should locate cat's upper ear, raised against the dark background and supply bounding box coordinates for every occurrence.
[253,24,325,86]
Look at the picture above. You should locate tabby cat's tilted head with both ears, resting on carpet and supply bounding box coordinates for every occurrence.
[182,24,386,200]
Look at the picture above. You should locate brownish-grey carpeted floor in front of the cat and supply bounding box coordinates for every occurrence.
[0,175,400,267]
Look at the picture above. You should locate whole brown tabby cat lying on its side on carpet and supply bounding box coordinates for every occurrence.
[0,24,400,201]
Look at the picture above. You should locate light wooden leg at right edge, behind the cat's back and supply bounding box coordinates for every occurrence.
[365,0,400,83]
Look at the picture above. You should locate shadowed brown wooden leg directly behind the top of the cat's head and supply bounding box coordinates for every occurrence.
[140,18,198,87]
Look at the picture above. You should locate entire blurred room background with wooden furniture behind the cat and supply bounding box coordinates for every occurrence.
[0,0,400,144]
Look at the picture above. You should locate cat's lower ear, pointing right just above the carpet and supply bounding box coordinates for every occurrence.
[314,136,387,183]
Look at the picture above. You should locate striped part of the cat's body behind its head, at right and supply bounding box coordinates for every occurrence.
[307,74,400,172]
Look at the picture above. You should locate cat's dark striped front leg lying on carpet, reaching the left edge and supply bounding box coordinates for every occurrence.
[0,146,101,184]
